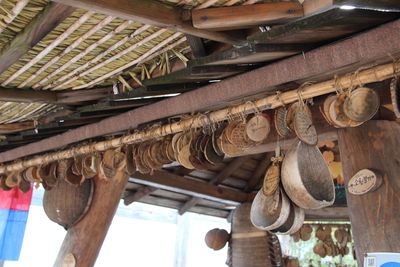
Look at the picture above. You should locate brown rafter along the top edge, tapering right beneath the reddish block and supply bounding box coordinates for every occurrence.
[50,0,243,45]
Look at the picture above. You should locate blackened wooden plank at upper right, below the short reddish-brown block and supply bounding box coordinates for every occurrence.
[247,8,399,44]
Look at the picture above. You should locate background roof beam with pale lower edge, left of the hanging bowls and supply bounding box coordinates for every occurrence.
[129,171,254,205]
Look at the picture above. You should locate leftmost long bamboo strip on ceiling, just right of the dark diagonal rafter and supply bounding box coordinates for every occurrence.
[1,11,94,87]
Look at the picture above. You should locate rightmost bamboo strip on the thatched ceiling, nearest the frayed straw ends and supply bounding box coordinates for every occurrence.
[72,30,182,90]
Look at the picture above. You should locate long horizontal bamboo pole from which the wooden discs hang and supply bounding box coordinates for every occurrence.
[0,60,400,173]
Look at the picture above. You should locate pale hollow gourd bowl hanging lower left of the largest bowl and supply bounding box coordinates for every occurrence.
[250,190,290,230]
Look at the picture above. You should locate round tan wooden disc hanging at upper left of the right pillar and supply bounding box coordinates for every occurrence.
[343,87,380,122]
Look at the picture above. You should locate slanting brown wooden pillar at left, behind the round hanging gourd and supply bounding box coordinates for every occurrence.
[54,171,128,267]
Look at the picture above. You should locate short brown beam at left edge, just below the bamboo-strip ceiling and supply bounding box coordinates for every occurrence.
[0,88,57,104]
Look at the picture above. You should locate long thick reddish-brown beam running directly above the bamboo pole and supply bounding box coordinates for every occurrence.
[0,17,400,162]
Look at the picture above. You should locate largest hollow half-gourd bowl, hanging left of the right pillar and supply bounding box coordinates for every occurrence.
[281,142,335,209]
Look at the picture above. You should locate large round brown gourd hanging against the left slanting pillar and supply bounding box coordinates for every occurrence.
[43,176,94,229]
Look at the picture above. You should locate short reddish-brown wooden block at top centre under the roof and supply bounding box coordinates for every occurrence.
[192,2,303,31]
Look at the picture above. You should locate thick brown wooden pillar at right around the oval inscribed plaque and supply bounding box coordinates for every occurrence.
[339,121,400,266]
